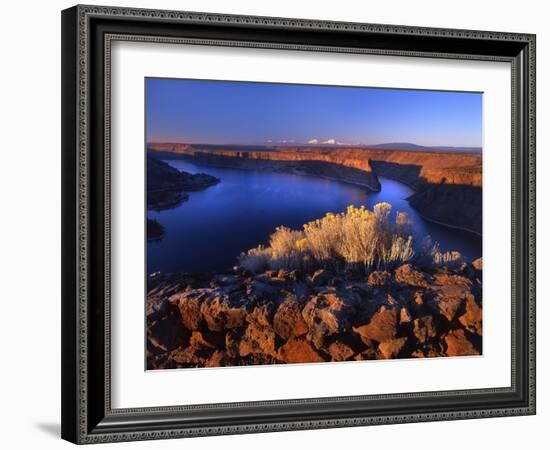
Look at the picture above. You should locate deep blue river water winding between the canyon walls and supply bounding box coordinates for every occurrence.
[147,160,481,273]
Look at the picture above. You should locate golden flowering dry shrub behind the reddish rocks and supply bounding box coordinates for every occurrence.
[239,203,420,273]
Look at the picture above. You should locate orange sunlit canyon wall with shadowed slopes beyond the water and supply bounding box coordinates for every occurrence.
[148,143,482,234]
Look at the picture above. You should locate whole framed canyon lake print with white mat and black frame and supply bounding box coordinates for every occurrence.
[62,6,535,443]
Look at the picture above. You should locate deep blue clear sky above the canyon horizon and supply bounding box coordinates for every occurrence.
[145,78,482,147]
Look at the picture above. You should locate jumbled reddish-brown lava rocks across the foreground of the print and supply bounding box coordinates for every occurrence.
[146,259,482,369]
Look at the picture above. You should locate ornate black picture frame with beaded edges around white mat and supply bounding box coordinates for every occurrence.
[62,6,535,444]
